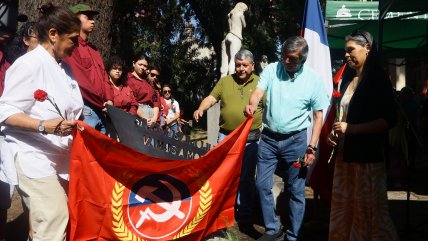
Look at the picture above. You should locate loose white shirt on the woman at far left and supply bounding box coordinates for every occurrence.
[0,45,83,181]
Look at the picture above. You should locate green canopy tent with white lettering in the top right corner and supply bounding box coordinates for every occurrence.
[326,0,428,58]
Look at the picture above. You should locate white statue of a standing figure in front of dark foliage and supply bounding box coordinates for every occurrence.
[220,2,248,77]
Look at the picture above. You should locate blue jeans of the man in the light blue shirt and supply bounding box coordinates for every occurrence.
[256,131,307,241]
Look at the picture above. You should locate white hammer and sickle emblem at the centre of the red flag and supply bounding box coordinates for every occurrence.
[135,181,185,228]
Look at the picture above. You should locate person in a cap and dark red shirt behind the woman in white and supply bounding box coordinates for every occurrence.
[64,4,113,134]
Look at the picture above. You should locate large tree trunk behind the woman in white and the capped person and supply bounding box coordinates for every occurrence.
[19,0,113,60]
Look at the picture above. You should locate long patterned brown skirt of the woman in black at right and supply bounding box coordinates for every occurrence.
[328,151,399,241]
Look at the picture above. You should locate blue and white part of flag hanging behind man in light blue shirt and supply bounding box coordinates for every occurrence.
[301,0,334,197]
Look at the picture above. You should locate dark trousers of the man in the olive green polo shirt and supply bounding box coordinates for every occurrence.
[217,132,259,218]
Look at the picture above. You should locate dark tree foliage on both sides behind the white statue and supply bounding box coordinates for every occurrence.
[112,0,304,117]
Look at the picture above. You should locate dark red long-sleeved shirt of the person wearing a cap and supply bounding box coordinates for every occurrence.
[64,36,114,109]
